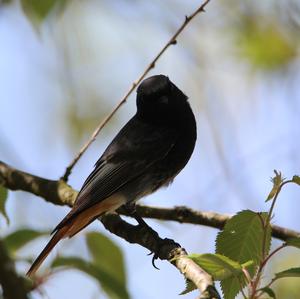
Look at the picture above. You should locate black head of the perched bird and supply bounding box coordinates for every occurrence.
[137,75,189,124]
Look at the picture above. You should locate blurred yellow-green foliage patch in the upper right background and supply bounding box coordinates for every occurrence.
[234,14,298,72]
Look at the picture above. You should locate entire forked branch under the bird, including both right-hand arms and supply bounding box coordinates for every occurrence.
[0,161,300,299]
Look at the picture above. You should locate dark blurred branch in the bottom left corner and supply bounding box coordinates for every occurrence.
[0,240,28,299]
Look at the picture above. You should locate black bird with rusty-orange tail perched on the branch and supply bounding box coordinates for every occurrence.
[27,75,196,276]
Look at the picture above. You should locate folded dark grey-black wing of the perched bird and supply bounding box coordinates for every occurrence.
[54,117,178,231]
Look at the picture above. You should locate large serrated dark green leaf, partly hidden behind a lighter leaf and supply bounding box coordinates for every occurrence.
[216,210,271,299]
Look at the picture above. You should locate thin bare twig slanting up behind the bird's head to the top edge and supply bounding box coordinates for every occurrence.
[61,0,210,182]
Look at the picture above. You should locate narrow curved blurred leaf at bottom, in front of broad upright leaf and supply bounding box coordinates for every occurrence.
[52,257,129,299]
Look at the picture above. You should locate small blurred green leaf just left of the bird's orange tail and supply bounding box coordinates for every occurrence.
[3,228,50,254]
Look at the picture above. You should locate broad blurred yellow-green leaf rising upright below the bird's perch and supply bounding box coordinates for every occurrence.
[86,232,126,287]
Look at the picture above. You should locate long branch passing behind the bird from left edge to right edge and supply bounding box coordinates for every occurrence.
[0,161,300,241]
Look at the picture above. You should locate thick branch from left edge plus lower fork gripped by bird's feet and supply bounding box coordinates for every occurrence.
[0,161,220,299]
